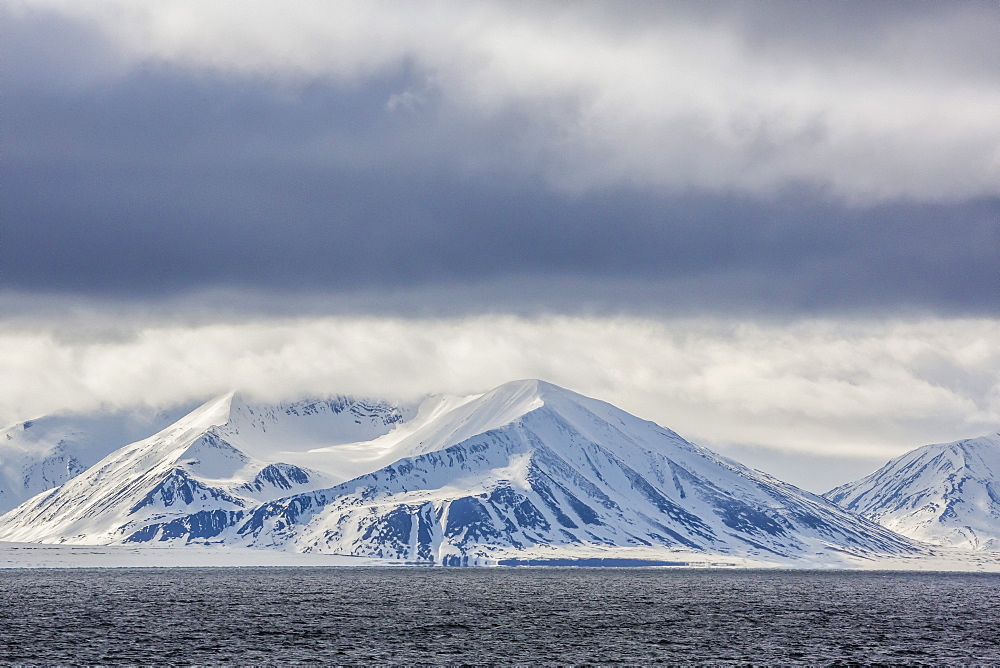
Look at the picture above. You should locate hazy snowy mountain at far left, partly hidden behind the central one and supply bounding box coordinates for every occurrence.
[0,406,194,513]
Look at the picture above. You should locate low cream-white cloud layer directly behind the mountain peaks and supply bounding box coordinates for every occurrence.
[0,314,1000,464]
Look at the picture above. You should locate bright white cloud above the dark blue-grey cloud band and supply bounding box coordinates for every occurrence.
[9,0,1000,201]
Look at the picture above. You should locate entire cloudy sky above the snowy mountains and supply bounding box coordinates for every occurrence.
[0,0,1000,491]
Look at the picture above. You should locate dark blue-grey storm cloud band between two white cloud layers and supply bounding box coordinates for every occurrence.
[0,2,1000,315]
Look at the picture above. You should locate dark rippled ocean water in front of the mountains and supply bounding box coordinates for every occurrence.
[0,568,1000,664]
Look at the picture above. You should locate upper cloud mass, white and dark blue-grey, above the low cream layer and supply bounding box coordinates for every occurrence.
[0,1,1000,316]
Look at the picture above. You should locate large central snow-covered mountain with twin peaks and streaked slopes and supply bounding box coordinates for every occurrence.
[0,381,920,564]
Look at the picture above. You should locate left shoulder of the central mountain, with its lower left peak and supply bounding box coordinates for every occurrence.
[0,393,410,544]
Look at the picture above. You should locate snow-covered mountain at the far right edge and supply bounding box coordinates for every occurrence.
[824,433,1000,550]
